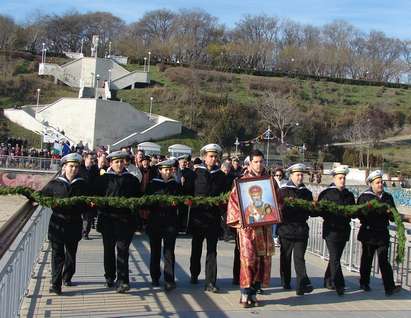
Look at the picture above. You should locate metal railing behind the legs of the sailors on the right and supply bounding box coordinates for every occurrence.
[307,217,411,288]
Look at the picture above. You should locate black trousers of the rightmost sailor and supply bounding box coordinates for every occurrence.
[360,243,395,291]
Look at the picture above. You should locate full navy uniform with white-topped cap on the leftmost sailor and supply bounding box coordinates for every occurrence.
[42,153,88,294]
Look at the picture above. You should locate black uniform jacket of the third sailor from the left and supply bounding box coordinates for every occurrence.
[147,178,182,231]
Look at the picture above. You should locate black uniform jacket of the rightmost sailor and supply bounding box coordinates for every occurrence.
[357,189,395,245]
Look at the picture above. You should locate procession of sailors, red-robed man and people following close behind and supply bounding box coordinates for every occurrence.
[43,144,401,308]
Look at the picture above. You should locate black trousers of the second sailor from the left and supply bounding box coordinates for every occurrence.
[102,228,134,284]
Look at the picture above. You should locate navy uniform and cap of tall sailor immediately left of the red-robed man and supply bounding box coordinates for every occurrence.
[190,144,226,292]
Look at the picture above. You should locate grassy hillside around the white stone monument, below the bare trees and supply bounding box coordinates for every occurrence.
[0,59,411,171]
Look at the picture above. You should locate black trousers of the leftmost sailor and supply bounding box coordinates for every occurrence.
[50,241,78,288]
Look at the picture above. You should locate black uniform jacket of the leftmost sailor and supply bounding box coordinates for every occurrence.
[41,175,89,243]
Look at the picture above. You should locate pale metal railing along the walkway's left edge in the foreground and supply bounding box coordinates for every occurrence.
[0,206,51,318]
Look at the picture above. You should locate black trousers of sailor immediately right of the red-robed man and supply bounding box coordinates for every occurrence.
[280,236,311,290]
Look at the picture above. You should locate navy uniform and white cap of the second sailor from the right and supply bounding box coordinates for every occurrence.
[318,166,355,296]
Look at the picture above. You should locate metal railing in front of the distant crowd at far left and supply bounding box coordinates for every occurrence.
[0,155,60,172]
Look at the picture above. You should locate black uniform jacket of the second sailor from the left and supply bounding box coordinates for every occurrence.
[94,168,140,231]
